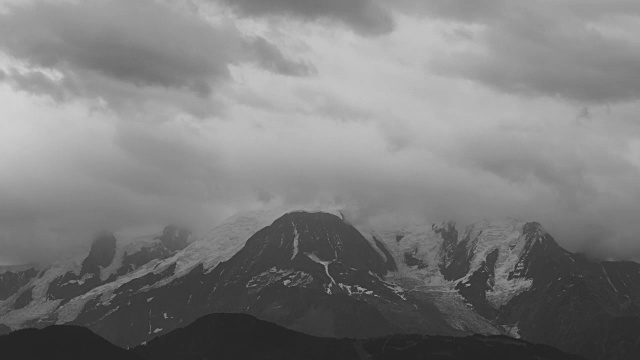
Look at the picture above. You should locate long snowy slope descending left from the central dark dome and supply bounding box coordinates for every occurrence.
[0,207,338,329]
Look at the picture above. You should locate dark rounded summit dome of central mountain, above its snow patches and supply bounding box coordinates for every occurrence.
[215,211,388,300]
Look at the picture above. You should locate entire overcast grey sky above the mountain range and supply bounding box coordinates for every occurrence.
[0,0,640,264]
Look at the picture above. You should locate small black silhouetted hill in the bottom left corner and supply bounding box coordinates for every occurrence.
[0,325,144,360]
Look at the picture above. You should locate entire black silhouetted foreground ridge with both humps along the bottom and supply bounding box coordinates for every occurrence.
[0,314,581,360]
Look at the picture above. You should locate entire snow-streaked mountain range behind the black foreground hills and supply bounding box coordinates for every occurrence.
[0,210,640,359]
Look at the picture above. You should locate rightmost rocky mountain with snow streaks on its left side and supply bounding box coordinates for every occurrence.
[430,223,640,359]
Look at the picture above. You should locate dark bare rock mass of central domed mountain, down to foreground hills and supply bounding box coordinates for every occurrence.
[75,212,464,346]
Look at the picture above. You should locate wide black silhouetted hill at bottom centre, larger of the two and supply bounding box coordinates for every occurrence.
[133,314,581,360]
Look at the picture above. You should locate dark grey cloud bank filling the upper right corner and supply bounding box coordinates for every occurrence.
[412,0,640,104]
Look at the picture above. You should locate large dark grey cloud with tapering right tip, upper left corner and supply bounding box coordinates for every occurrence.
[0,0,313,115]
